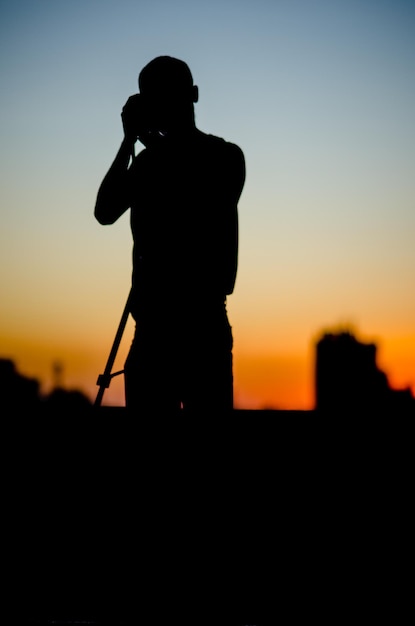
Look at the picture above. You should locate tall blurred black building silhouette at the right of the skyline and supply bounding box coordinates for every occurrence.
[315,331,415,416]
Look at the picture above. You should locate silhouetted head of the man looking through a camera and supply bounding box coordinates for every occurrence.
[138,56,199,130]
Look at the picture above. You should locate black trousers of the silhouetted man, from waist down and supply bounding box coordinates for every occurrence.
[124,303,233,413]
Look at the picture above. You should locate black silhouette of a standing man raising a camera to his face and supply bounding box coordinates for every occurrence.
[95,56,245,412]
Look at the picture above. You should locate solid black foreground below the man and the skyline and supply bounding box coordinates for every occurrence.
[3,408,414,626]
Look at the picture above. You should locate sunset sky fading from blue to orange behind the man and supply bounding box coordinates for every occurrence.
[0,0,415,410]
